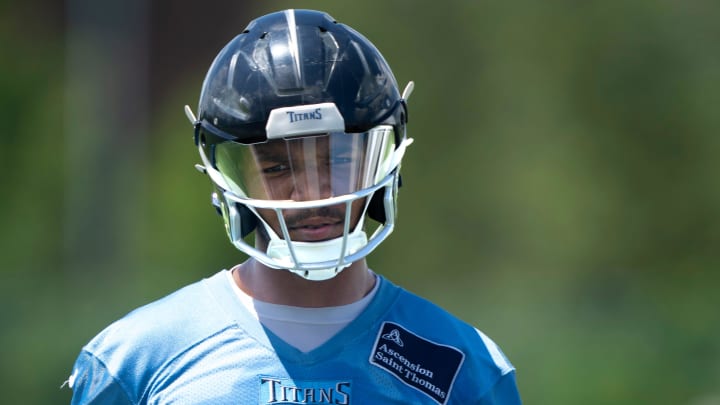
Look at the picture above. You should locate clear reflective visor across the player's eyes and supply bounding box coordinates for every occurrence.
[215,125,396,201]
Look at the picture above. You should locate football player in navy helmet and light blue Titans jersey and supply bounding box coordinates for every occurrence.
[70,10,520,404]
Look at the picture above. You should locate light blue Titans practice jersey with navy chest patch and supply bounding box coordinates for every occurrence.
[70,271,520,405]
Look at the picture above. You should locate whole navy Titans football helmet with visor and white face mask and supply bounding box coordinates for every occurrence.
[186,10,412,280]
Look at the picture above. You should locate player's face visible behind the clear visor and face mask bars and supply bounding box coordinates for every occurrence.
[248,136,364,242]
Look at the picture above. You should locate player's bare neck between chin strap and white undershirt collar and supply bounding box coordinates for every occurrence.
[233,259,375,307]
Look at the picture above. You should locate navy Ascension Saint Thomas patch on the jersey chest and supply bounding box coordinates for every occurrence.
[370,322,465,405]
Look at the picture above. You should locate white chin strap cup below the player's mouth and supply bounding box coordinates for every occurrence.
[267,231,368,281]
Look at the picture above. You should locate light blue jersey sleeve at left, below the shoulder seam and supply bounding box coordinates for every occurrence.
[68,351,133,405]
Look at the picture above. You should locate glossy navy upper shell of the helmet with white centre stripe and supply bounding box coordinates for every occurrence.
[198,10,406,143]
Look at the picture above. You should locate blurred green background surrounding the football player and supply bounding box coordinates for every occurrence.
[0,0,720,405]
